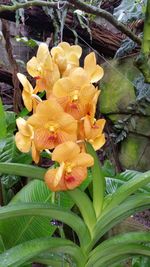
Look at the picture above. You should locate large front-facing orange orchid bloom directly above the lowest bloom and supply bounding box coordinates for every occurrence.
[28,98,77,150]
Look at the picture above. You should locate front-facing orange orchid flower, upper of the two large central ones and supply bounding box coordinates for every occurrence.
[53,68,99,120]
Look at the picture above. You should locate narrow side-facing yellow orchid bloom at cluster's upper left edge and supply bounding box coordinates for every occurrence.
[17,73,40,111]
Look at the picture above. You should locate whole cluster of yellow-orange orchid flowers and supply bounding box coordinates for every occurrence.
[15,42,105,191]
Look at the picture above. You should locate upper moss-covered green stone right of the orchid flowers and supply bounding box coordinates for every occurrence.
[100,60,139,114]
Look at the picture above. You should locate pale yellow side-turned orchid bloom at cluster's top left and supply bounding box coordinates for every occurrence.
[27,43,60,94]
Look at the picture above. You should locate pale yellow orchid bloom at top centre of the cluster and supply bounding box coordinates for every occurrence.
[51,42,82,74]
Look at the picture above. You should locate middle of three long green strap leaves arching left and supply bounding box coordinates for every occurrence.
[0,203,91,249]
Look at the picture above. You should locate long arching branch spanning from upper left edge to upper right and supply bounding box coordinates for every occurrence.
[0,0,142,45]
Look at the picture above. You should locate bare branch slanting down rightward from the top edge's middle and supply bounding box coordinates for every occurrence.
[69,0,142,45]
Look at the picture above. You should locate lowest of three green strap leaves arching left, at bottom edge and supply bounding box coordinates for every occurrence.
[0,238,85,267]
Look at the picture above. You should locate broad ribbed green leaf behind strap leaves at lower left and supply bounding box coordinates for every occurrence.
[0,180,72,251]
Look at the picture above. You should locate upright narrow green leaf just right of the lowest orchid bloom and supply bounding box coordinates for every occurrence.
[86,143,105,217]
